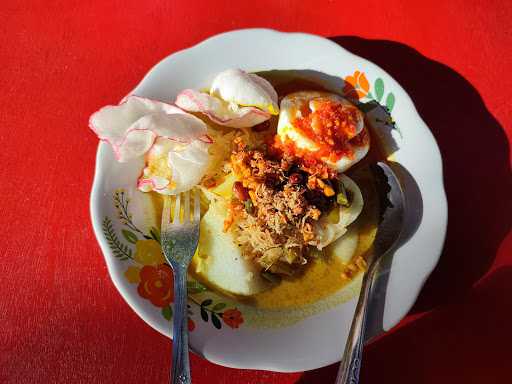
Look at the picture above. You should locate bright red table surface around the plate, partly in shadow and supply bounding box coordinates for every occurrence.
[0,0,512,384]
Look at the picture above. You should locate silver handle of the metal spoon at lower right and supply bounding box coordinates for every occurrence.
[335,263,376,384]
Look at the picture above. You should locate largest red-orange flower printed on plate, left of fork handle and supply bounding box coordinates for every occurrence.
[137,264,174,308]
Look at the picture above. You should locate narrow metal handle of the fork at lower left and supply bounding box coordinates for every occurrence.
[171,266,192,384]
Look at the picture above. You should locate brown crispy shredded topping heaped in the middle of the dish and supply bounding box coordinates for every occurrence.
[225,137,339,274]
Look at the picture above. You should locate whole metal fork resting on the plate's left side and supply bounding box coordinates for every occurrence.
[161,190,200,384]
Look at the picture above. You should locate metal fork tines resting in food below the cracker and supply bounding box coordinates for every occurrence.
[162,189,201,226]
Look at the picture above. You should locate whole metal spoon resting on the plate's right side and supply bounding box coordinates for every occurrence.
[335,162,404,384]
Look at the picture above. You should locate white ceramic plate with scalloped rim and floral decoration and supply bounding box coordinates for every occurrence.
[91,29,447,372]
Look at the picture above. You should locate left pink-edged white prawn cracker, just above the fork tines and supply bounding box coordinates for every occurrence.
[89,96,211,194]
